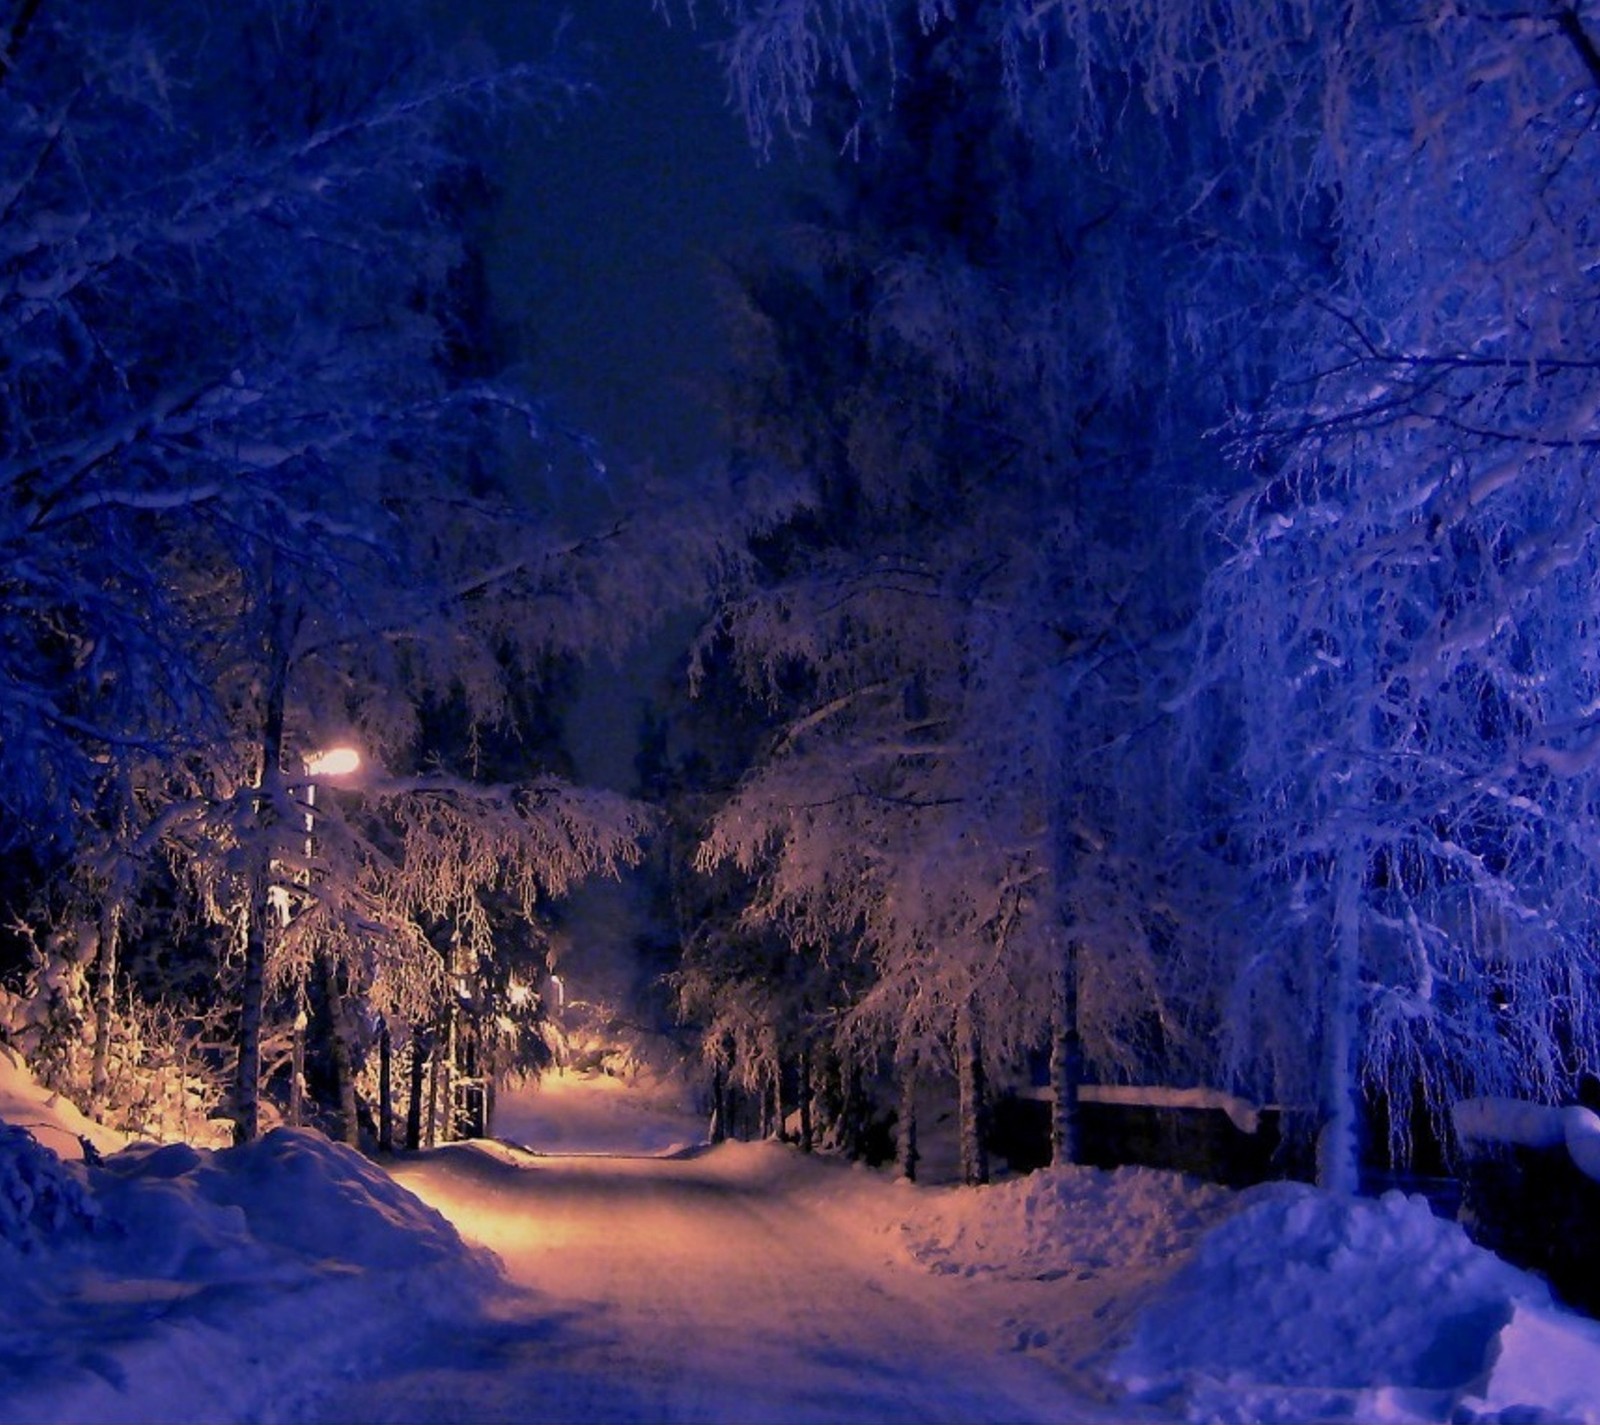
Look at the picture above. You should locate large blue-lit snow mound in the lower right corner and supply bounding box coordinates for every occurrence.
[1110,1184,1600,1422]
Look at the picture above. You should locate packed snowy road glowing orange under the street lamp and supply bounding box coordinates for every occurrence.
[300,1145,1128,1422]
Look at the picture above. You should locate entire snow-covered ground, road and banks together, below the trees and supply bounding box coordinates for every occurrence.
[0,1051,1600,1425]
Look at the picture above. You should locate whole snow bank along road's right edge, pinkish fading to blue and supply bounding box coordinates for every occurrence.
[898,1157,1600,1425]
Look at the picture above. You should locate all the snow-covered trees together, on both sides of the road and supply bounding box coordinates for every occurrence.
[0,0,1600,1188]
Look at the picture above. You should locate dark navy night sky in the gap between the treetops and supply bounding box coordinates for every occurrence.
[442,0,819,472]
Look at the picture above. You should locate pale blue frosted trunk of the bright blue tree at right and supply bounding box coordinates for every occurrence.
[1317,848,1365,1195]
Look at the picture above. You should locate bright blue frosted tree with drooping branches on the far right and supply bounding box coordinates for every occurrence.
[691,0,1600,1187]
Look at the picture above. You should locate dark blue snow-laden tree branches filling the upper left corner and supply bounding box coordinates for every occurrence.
[0,5,544,843]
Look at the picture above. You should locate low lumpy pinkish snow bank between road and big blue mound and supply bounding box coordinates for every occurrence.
[901,1168,1238,1281]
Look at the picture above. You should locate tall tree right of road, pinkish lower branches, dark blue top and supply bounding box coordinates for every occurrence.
[675,5,1209,1174]
